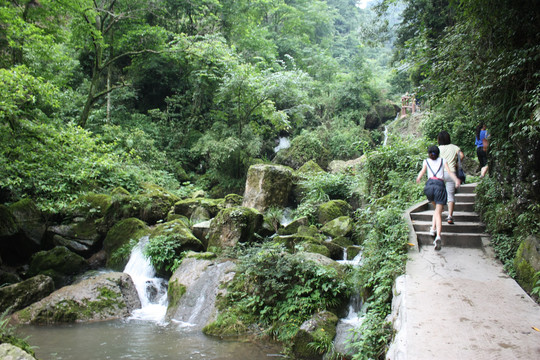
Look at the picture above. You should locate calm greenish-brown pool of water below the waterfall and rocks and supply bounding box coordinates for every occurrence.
[18,320,283,360]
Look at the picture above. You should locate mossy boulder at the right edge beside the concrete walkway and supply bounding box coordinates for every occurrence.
[514,235,540,292]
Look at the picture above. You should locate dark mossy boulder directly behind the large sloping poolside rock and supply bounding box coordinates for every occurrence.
[28,246,88,288]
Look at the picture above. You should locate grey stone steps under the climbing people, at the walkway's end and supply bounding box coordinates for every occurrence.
[409,184,488,248]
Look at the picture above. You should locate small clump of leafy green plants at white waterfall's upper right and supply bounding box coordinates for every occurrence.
[144,235,185,274]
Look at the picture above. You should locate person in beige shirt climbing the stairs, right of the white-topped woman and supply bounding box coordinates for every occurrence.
[437,130,465,224]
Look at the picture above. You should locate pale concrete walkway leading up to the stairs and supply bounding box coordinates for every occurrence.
[387,184,540,360]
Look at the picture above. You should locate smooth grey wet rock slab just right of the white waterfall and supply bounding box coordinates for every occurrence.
[167,254,235,329]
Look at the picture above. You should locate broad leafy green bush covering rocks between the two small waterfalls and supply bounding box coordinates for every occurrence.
[227,243,348,341]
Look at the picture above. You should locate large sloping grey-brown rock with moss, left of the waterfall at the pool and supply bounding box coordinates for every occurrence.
[12,273,141,325]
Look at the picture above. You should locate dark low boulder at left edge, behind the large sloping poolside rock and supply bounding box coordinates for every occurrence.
[0,275,54,313]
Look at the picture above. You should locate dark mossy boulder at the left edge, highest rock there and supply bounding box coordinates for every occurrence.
[0,199,46,264]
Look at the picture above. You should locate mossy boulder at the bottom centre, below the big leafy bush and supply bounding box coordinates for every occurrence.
[291,311,338,360]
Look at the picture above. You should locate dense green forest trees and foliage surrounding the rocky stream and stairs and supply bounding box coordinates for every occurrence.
[0,0,540,359]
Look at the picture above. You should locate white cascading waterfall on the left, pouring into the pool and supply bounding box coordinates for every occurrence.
[124,236,167,323]
